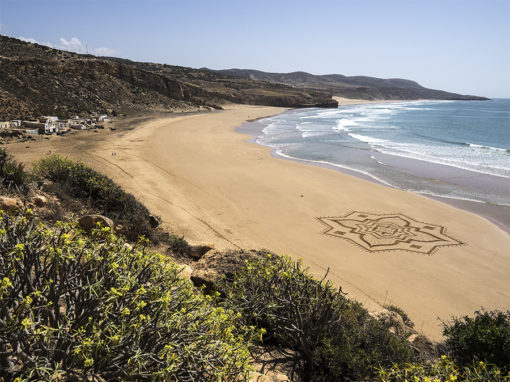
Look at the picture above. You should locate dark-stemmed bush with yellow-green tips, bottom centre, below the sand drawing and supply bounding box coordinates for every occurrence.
[220,256,413,381]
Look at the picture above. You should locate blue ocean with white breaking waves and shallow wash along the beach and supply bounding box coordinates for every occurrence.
[239,99,510,227]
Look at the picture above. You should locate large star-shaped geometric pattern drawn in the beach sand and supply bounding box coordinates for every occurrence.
[317,211,464,255]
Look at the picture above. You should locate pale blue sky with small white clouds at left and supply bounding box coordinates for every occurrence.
[0,0,510,98]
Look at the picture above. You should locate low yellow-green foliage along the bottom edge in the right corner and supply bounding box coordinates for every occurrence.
[378,356,510,382]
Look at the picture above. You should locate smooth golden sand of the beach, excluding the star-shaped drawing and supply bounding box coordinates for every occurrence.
[8,106,510,339]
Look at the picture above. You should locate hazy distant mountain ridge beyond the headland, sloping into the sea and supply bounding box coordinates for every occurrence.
[216,69,487,100]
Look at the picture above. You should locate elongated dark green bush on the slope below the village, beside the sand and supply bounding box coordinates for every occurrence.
[33,154,153,240]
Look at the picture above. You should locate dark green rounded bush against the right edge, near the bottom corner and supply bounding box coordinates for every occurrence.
[443,310,510,373]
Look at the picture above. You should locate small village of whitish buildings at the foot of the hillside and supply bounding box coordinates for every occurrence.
[0,113,113,143]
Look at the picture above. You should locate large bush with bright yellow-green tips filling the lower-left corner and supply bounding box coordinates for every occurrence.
[0,210,252,381]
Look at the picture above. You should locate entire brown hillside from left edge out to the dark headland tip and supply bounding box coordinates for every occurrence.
[0,36,337,120]
